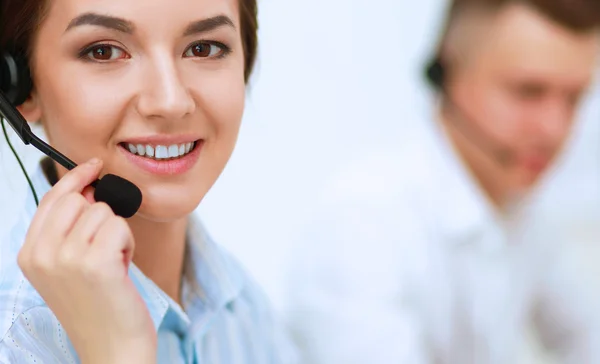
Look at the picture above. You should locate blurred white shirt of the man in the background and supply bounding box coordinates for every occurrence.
[288,116,600,364]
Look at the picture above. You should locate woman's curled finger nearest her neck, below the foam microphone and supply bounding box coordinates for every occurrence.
[87,216,135,271]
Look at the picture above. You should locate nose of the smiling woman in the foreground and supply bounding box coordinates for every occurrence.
[137,57,196,119]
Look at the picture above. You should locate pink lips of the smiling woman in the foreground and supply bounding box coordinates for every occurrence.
[119,138,204,176]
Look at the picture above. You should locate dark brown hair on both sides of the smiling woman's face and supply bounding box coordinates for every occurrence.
[0,0,258,82]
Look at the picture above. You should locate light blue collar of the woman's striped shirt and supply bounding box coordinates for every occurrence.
[27,159,244,330]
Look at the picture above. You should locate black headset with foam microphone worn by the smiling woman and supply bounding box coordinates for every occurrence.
[0,48,142,218]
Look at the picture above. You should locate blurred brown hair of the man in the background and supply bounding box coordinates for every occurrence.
[449,0,600,32]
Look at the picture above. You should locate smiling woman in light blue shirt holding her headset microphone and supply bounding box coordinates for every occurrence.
[0,0,296,364]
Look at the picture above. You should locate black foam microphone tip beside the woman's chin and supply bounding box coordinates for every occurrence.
[94,174,142,219]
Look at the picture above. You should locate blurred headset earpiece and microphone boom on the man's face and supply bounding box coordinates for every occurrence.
[425,57,513,166]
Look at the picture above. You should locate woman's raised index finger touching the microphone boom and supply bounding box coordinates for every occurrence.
[27,159,102,240]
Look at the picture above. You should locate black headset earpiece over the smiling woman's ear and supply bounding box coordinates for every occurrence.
[0,51,33,106]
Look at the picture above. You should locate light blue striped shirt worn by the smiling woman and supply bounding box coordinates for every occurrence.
[0,163,297,364]
